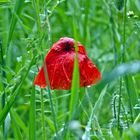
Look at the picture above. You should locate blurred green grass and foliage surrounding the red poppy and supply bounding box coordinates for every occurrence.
[0,0,140,140]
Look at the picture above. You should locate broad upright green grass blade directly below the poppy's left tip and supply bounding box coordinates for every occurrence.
[29,86,36,140]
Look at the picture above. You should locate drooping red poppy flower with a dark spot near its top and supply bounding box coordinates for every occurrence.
[34,37,101,89]
